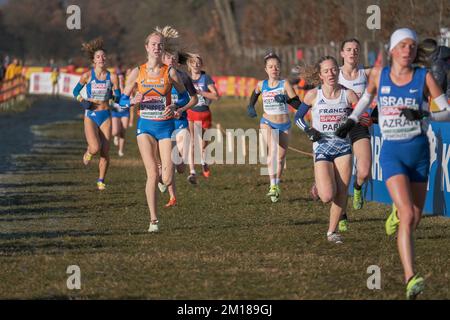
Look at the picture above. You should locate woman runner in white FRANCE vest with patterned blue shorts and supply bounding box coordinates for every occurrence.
[295,56,358,243]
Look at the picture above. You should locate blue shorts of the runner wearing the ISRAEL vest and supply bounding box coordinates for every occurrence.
[380,135,430,182]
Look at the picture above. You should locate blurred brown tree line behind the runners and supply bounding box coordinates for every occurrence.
[0,0,450,76]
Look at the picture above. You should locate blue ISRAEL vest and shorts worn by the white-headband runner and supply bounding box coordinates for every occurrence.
[378,66,430,182]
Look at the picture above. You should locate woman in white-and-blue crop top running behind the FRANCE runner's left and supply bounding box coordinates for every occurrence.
[247,53,301,202]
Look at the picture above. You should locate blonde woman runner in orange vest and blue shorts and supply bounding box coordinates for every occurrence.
[119,28,189,232]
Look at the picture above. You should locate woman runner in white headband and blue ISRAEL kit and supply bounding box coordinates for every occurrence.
[336,28,450,299]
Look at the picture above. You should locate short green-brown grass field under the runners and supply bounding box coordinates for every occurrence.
[0,99,450,300]
